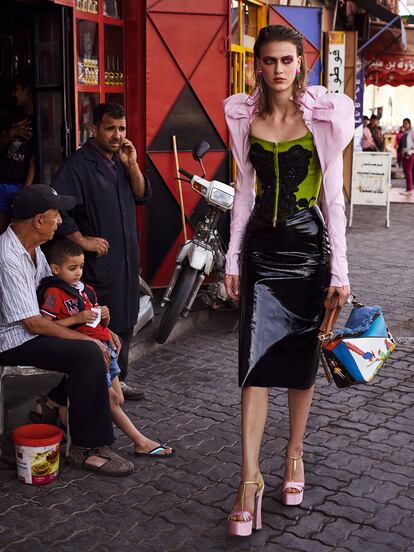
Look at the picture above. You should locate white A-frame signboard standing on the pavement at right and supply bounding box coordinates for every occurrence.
[349,151,391,227]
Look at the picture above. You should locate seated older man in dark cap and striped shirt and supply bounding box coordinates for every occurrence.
[0,184,133,476]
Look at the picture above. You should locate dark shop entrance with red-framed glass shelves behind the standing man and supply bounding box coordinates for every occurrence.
[0,0,130,184]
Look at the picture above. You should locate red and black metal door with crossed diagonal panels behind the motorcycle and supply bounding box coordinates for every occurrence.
[145,0,230,287]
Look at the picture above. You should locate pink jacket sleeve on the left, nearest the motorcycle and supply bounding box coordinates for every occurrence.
[224,94,255,275]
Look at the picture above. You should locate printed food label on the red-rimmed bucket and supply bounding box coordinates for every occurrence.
[15,443,60,485]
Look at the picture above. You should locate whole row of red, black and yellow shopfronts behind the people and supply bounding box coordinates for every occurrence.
[0,0,340,287]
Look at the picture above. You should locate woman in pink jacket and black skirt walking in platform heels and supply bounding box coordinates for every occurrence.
[224,25,354,536]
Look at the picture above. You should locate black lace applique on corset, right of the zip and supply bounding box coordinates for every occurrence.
[278,144,314,216]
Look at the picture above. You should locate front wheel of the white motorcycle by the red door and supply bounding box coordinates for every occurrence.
[155,266,198,343]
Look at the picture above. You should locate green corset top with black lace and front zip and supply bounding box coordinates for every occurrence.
[249,130,322,226]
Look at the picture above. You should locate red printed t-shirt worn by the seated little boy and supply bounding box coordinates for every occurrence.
[40,284,111,341]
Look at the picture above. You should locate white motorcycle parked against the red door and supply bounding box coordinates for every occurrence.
[155,141,234,343]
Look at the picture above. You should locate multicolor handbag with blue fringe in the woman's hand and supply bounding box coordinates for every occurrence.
[319,297,396,387]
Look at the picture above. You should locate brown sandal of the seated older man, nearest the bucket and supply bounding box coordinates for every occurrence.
[66,445,134,477]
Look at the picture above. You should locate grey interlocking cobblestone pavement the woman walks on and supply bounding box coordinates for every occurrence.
[0,205,414,552]
